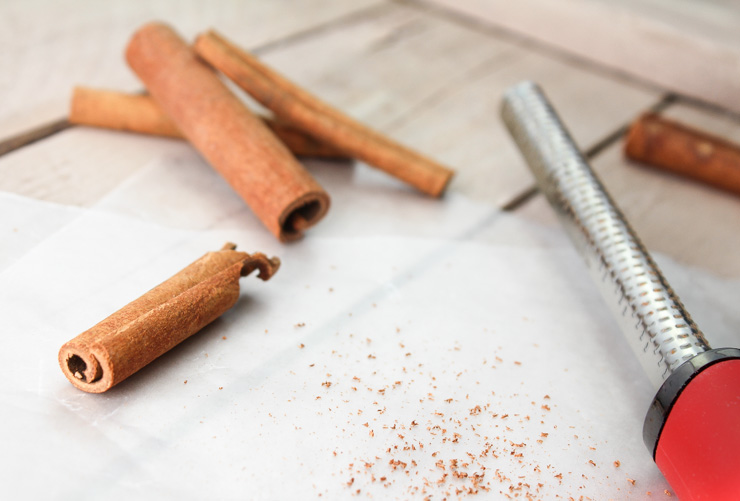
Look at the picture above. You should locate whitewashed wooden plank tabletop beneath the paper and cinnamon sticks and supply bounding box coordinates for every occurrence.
[0,0,740,498]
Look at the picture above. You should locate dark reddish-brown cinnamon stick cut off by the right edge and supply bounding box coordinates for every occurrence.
[624,113,740,195]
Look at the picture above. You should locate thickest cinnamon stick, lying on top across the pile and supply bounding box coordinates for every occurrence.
[126,23,329,242]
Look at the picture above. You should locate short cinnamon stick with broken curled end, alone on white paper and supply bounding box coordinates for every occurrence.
[59,244,280,393]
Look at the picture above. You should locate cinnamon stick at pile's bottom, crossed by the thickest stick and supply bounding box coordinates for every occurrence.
[69,87,348,160]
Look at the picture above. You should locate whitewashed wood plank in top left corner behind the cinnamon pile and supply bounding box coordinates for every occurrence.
[0,0,382,140]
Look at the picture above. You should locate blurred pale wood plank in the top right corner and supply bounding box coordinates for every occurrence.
[421,0,740,111]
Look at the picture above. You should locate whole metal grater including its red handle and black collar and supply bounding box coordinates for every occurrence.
[501,82,740,500]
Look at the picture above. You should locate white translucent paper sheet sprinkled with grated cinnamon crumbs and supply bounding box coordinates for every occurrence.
[0,154,740,501]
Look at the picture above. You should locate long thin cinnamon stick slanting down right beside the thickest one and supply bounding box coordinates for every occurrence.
[194,31,454,197]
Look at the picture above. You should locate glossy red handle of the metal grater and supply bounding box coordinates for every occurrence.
[655,359,740,501]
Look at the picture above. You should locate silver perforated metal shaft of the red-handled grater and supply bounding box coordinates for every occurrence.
[501,82,710,389]
